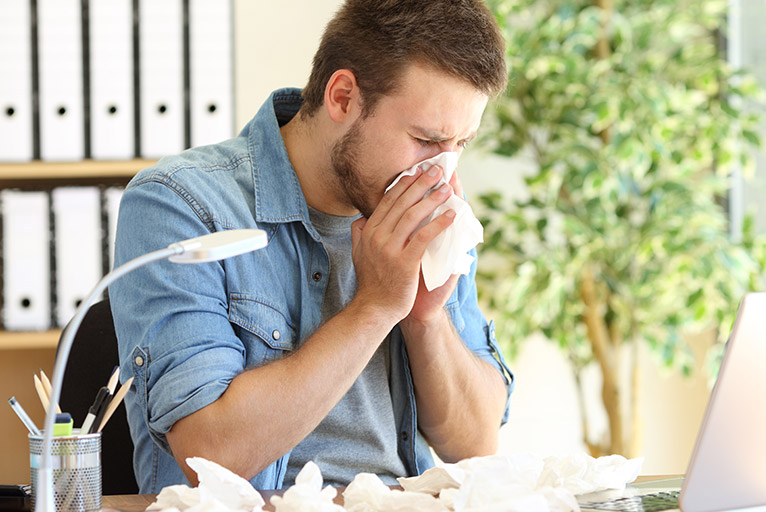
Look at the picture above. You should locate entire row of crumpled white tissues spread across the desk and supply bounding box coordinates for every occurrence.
[147,454,643,512]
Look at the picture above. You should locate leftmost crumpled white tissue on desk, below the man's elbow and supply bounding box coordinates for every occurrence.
[146,457,266,512]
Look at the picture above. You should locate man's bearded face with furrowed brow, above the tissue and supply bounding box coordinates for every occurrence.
[331,65,487,217]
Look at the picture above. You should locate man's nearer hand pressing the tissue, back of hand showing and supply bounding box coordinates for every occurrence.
[351,166,455,323]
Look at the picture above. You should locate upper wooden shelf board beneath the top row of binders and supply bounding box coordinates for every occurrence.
[0,158,156,181]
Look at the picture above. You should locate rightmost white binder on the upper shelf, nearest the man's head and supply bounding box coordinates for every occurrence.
[189,0,234,146]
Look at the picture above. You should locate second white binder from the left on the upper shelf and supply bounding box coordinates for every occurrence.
[37,0,85,160]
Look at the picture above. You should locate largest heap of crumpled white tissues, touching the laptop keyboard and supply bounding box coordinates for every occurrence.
[398,453,643,512]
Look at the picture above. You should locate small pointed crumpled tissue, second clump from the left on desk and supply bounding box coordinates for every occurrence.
[271,461,343,512]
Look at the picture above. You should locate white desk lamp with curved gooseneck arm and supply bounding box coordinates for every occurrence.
[35,229,268,512]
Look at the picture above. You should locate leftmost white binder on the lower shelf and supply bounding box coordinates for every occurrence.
[0,190,51,331]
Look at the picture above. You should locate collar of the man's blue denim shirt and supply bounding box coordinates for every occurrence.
[245,88,320,240]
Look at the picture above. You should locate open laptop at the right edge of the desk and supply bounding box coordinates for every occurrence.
[578,293,766,512]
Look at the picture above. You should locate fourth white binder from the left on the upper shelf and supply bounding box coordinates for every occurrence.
[138,0,185,158]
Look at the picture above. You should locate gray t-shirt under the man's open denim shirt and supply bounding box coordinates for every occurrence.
[284,208,406,487]
